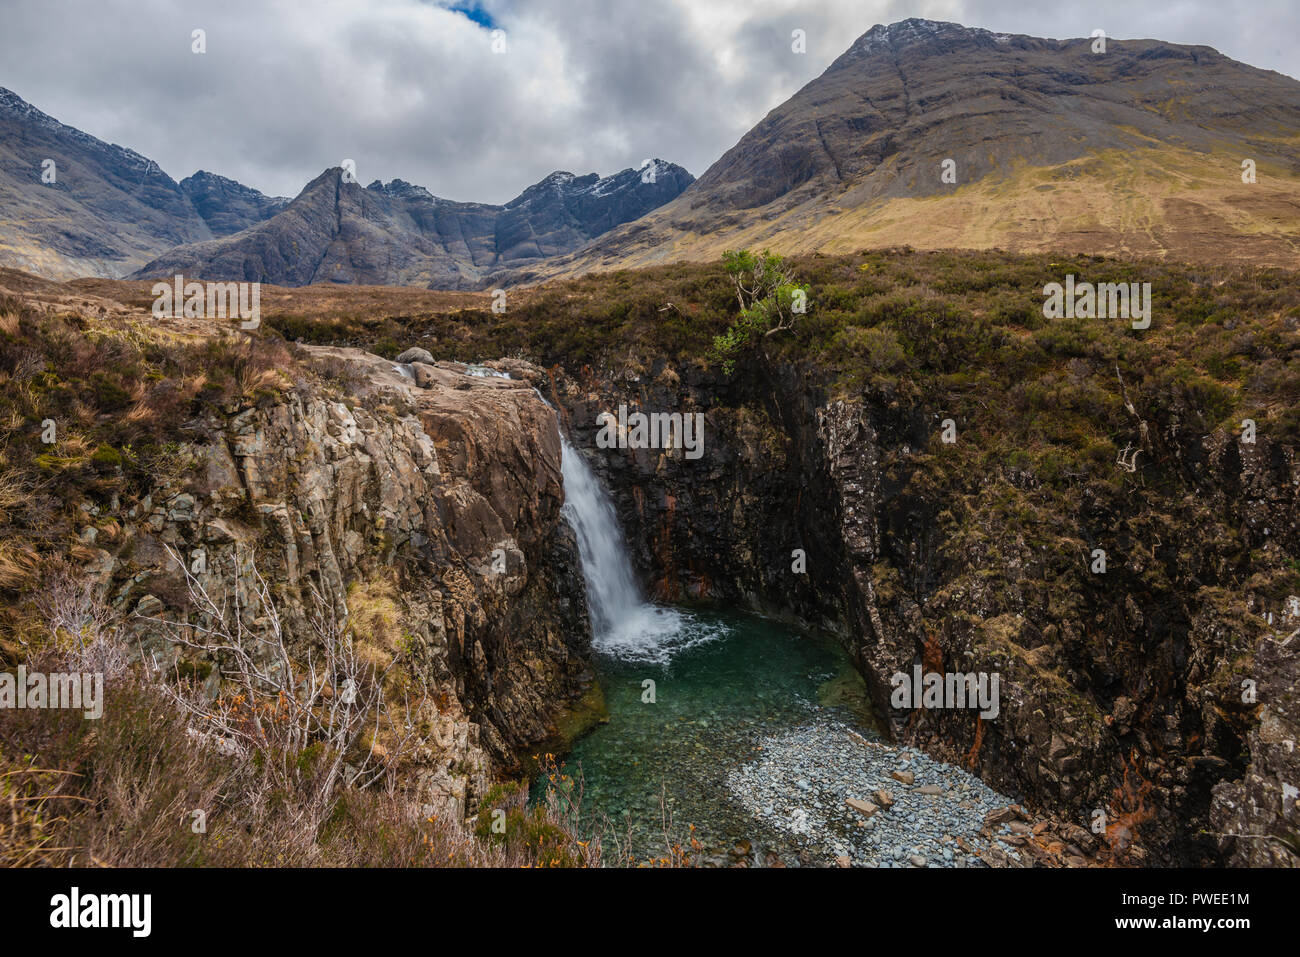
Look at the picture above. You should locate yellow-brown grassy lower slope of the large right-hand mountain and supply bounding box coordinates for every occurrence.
[528,146,1300,281]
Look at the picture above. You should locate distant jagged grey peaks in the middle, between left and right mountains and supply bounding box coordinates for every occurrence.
[134,160,693,289]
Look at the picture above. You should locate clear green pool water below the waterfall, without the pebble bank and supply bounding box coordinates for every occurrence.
[533,606,871,861]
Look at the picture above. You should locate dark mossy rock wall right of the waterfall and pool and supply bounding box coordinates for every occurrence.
[556,363,1300,865]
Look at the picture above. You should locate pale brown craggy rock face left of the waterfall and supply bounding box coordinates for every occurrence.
[110,348,590,811]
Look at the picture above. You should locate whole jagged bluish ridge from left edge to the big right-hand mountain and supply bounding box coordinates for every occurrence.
[0,88,693,289]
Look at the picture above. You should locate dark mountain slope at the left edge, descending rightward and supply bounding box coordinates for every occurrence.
[0,87,287,278]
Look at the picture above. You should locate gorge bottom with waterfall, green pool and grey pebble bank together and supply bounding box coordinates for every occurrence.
[553,439,1021,867]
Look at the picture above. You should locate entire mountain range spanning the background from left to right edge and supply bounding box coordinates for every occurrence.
[17,20,1300,289]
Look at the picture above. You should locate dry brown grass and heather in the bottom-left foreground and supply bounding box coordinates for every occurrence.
[0,663,599,867]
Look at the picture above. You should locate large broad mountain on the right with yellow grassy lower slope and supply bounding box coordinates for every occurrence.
[514,20,1300,280]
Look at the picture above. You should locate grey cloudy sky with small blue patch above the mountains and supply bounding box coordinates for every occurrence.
[0,0,1300,203]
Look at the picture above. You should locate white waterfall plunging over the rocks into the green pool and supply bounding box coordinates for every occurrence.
[560,434,719,663]
